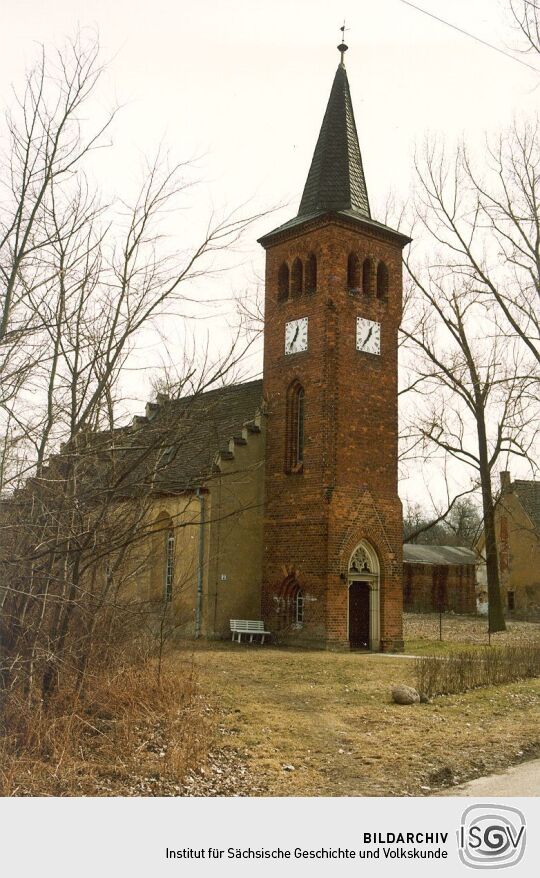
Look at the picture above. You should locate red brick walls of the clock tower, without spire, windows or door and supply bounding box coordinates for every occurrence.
[263,218,402,649]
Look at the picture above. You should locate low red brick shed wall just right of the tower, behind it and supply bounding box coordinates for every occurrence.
[403,563,476,613]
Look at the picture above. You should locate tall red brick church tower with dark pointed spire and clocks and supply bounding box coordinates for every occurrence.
[260,44,409,651]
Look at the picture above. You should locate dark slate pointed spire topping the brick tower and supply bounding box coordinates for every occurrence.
[298,43,371,219]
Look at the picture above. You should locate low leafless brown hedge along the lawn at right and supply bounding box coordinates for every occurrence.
[415,644,540,697]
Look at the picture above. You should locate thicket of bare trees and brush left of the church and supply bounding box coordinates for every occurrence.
[0,32,264,716]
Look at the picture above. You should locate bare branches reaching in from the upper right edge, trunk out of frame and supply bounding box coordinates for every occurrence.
[402,131,540,365]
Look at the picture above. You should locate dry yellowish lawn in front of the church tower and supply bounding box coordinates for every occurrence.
[175,644,540,796]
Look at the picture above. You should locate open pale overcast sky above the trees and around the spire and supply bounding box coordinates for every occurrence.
[0,0,540,506]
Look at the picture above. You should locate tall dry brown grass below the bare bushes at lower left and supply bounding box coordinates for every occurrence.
[0,662,212,796]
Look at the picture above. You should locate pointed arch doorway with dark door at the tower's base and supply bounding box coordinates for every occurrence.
[348,540,381,652]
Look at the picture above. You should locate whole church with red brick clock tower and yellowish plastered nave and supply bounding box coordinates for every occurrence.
[131,43,410,652]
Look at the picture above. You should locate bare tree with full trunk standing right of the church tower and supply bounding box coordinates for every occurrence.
[403,139,538,631]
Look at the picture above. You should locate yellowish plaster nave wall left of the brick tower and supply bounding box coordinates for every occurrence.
[111,412,265,638]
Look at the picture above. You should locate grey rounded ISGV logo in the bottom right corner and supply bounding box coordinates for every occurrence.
[458,805,526,869]
